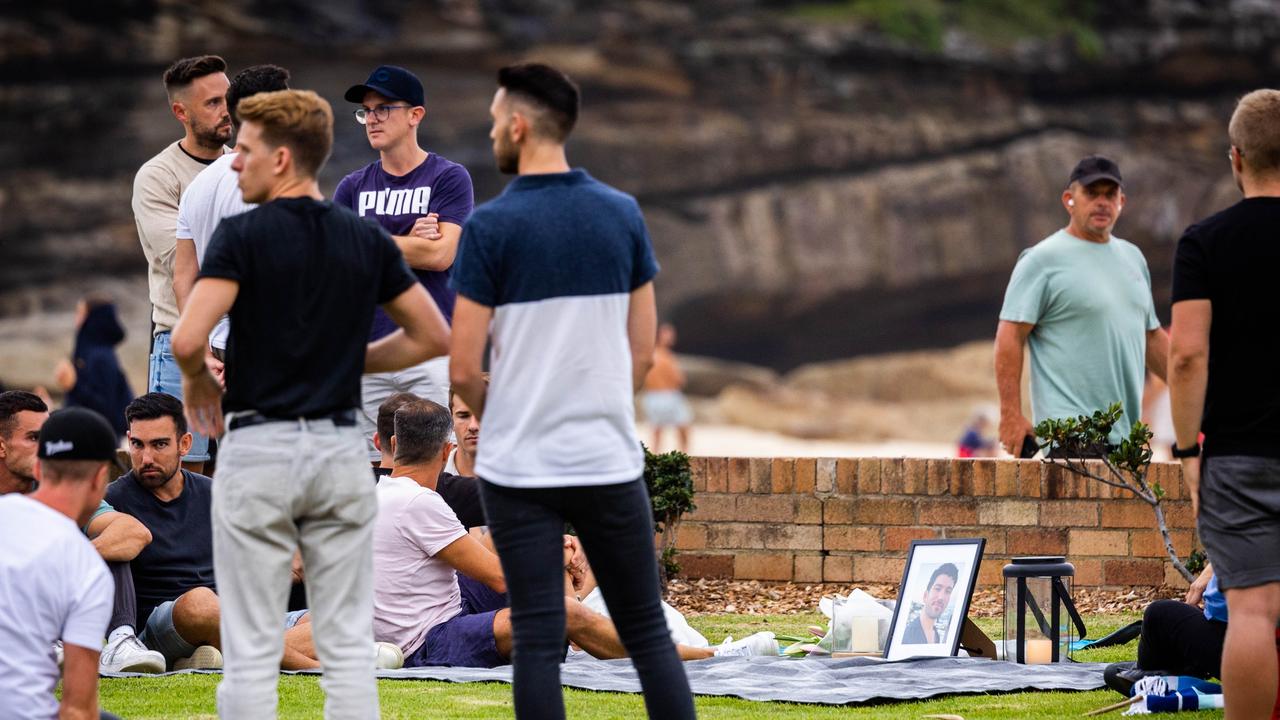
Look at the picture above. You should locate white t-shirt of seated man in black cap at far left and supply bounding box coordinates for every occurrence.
[0,493,115,720]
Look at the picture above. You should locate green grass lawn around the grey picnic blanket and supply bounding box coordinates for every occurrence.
[101,614,1221,720]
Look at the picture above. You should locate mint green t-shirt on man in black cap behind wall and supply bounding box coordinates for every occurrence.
[1000,229,1160,443]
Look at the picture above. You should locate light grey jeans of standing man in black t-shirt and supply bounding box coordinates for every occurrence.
[212,420,378,720]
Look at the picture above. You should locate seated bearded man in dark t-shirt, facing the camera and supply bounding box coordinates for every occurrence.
[106,392,315,670]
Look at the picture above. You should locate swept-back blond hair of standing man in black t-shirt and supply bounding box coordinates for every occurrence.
[236,90,333,177]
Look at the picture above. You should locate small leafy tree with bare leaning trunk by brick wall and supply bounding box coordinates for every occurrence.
[1036,402,1194,583]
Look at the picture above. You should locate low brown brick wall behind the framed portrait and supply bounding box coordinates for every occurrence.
[677,457,1198,587]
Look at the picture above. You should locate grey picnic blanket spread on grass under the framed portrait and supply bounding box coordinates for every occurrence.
[108,657,1105,705]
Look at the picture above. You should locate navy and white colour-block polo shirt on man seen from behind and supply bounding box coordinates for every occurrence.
[453,169,658,488]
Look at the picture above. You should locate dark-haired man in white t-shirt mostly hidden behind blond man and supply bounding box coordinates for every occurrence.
[173,65,289,366]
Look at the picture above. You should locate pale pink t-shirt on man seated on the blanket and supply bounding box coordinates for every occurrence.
[374,478,467,656]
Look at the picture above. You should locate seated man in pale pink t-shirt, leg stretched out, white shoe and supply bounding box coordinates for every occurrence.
[374,400,777,667]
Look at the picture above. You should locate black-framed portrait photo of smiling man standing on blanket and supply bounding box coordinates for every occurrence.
[884,538,987,660]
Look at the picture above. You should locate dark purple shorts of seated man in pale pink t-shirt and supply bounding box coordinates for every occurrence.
[404,573,509,667]
